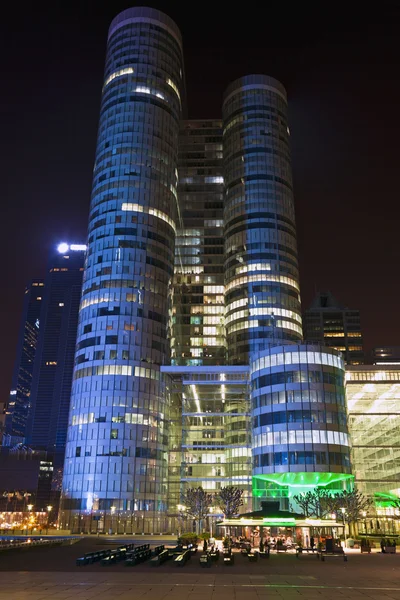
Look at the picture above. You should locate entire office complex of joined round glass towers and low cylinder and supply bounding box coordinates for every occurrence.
[60,8,351,533]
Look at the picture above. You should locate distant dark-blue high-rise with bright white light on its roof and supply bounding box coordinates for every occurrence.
[27,244,86,485]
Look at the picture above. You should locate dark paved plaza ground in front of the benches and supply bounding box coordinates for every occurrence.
[0,538,400,600]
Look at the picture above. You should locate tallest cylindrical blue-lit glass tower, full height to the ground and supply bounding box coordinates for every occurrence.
[60,8,183,532]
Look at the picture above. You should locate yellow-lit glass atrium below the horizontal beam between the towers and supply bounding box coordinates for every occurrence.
[162,366,251,517]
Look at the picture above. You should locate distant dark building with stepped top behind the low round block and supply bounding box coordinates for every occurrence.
[303,292,364,365]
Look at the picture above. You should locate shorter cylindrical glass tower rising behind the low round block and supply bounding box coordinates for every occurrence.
[222,75,302,364]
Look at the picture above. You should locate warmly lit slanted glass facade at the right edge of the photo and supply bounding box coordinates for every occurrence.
[346,365,400,502]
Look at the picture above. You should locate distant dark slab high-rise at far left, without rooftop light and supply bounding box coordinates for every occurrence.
[3,279,44,445]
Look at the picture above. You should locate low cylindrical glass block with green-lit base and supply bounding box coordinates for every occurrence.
[250,345,352,498]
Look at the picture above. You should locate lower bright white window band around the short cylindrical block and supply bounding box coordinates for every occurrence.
[253,429,350,448]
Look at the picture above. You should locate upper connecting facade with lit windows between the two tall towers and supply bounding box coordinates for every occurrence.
[171,120,226,366]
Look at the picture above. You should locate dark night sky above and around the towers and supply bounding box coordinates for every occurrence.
[0,0,400,400]
